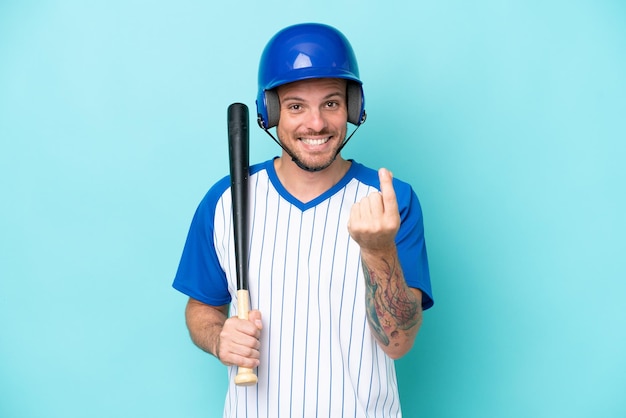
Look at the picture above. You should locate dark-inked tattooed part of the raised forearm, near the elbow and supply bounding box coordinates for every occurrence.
[363,259,421,346]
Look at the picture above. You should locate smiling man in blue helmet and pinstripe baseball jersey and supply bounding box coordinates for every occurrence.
[174,24,433,417]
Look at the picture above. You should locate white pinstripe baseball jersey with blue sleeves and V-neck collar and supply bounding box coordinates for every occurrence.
[174,161,432,418]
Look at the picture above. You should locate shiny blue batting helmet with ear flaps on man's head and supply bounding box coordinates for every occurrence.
[256,23,365,130]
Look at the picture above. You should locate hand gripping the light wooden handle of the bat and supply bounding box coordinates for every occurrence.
[216,310,263,369]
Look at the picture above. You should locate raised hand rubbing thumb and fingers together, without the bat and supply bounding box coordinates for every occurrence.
[348,168,400,252]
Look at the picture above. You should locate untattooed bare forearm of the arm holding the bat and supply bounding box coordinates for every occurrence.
[185,299,226,358]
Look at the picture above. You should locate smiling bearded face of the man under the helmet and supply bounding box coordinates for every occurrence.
[276,78,348,171]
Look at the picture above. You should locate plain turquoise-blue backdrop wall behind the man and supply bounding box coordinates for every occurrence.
[0,0,626,418]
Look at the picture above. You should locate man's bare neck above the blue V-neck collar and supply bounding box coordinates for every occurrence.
[274,152,351,203]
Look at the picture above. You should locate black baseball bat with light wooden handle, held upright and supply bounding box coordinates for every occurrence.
[228,103,257,386]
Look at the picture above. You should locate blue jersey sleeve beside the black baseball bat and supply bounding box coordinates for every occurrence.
[172,178,231,306]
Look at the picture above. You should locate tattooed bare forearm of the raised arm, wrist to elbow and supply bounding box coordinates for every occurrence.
[361,248,422,359]
